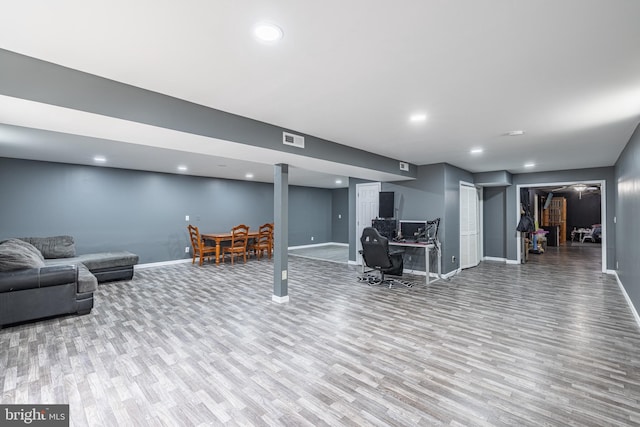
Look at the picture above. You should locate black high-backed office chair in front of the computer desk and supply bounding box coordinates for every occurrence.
[359,227,412,288]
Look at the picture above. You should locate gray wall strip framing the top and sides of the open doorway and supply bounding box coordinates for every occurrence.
[502,167,617,270]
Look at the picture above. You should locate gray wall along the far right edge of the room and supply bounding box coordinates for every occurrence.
[614,122,640,310]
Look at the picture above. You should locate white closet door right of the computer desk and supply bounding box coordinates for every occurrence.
[460,184,480,268]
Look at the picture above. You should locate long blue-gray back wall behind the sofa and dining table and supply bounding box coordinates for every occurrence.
[0,158,332,263]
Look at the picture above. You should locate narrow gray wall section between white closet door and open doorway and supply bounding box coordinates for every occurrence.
[482,187,507,258]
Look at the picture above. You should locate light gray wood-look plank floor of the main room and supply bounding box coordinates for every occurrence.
[0,248,640,426]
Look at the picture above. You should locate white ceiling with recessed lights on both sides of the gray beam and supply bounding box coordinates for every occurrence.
[0,0,640,187]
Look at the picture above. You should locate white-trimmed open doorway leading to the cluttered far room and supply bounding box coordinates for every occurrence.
[516,180,607,273]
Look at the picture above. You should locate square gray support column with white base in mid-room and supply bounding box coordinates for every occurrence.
[272,163,289,303]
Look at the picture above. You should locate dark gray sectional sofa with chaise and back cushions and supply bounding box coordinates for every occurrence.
[0,236,138,327]
